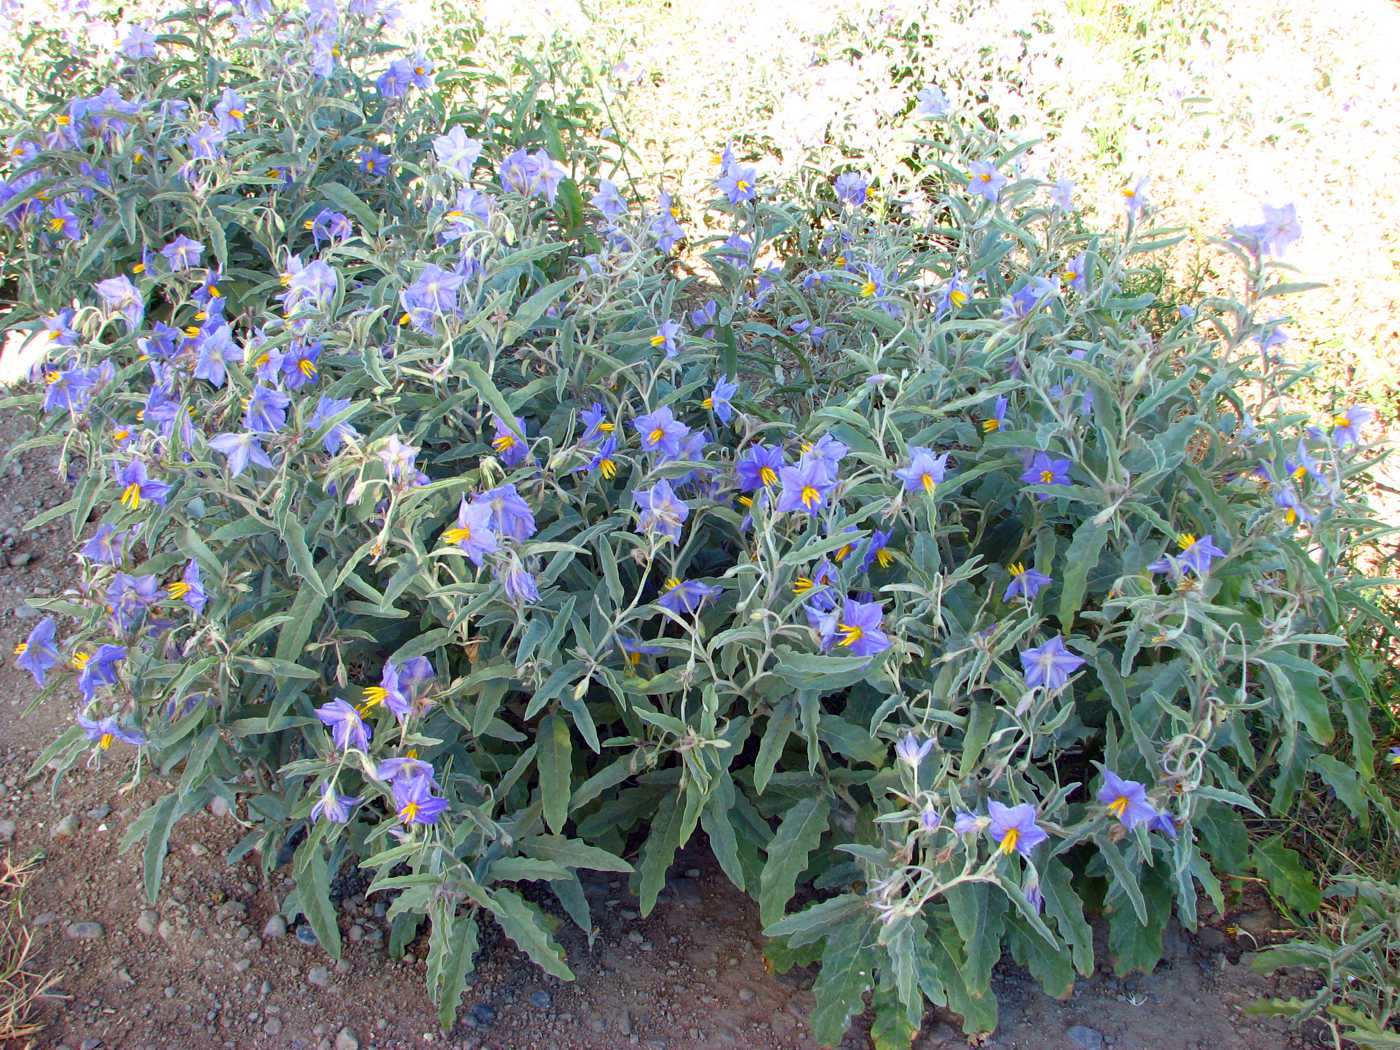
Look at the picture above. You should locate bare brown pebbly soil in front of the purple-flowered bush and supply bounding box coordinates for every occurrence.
[0,413,1316,1050]
